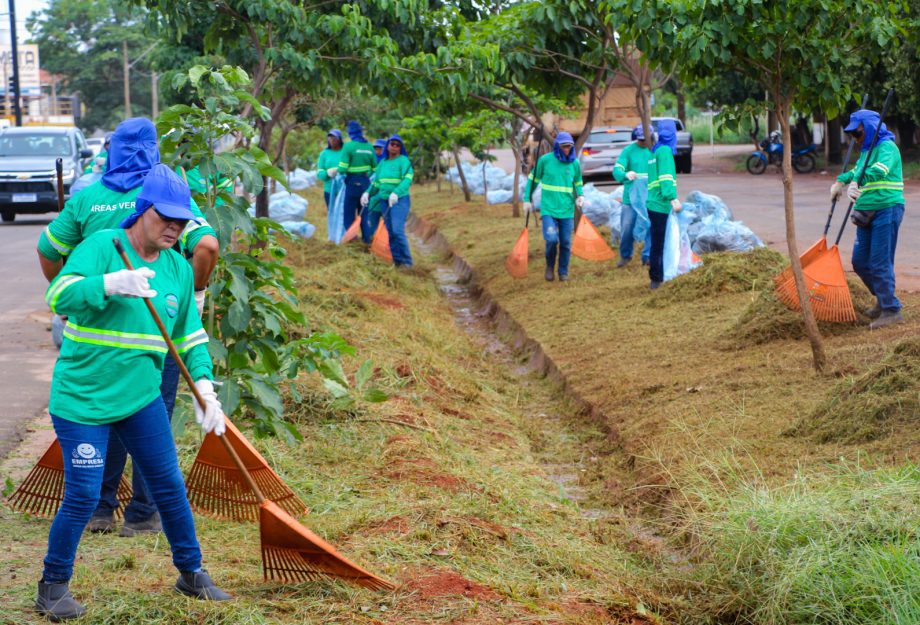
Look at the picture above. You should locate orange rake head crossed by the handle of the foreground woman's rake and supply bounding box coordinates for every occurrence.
[185,420,309,521]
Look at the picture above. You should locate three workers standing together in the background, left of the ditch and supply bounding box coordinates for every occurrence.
[317,121,415,269]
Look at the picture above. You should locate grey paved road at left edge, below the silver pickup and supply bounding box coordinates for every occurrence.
[0,215,57,459]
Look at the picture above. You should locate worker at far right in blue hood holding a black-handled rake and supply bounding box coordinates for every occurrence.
[831,110,904,329]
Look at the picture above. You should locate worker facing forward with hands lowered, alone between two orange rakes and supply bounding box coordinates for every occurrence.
[524,132,585,282]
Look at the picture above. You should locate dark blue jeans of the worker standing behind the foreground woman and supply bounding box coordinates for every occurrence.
[93,354,179,523]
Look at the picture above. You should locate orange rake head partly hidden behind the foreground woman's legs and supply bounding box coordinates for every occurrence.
[7,438,131,518]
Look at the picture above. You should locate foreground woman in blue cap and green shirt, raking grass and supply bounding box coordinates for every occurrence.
[35,164,230,621]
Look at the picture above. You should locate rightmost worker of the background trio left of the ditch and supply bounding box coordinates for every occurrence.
[361,135,415,268]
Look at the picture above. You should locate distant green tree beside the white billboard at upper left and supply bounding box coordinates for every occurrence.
[26,0,152,130]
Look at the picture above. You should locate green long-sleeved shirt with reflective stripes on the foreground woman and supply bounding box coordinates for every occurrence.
[45,229,213,425]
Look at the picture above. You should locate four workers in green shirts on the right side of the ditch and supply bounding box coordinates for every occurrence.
[524,110,904,329]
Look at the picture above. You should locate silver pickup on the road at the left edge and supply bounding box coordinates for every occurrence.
[0,126,93,222]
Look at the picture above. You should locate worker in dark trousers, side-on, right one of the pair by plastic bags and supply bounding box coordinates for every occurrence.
[647,119,681,289]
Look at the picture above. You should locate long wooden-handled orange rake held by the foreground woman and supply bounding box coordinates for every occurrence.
[114,238,395,590]
